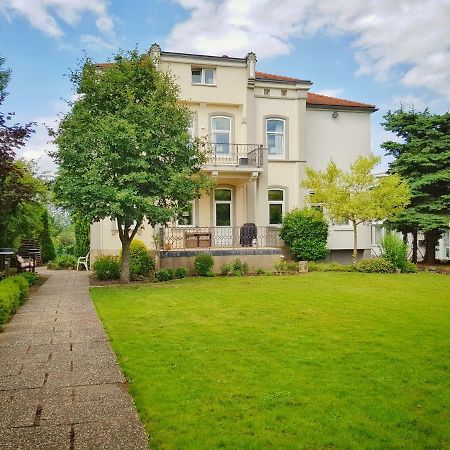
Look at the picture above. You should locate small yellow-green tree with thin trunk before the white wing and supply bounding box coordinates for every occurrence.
[302,155,409,262]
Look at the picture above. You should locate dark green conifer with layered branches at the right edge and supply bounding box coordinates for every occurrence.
[381,109,450,264]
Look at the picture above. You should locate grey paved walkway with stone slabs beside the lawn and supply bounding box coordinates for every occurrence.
[0,270,148,450]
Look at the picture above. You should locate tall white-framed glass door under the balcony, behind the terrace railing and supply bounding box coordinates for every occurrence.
[214,188,233,247]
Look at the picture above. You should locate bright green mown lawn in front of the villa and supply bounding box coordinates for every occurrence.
[91,273,450,449]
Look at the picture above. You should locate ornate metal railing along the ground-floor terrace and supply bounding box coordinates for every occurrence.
[160,226,282,250]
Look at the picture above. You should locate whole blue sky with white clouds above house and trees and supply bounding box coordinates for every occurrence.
[0,0,450,173]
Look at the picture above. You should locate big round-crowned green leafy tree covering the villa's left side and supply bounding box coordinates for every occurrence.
[55,50,205,282]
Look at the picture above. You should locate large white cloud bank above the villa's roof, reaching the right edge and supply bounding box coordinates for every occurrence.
[166,0,450,100]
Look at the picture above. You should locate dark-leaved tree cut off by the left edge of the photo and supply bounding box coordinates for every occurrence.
[0,57,43,245]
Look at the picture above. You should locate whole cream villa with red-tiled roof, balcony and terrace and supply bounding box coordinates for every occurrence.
[91,44,376,267]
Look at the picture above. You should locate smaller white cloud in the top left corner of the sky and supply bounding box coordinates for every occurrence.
[0,0,114,37]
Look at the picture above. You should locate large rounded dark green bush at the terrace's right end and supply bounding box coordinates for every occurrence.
[280,208,328,261]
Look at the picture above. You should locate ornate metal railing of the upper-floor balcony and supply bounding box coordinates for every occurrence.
[205,144,263,168]
